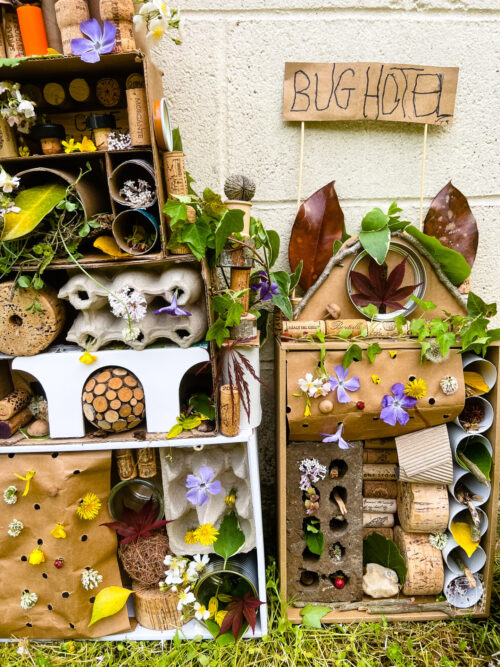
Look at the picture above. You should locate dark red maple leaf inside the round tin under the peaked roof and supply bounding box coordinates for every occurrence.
[351,257,422,313]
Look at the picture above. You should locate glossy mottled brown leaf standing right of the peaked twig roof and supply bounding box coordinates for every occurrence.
[424,181,479,267]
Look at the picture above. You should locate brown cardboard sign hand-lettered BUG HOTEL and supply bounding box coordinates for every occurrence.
[283,63,458,125]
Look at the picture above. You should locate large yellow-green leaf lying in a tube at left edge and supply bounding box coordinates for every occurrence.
[2,183,66,241]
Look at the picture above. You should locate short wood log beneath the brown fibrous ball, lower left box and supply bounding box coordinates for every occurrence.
[132,582,182,630]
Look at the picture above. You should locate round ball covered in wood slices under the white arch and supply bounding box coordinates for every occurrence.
[82,366,146,433]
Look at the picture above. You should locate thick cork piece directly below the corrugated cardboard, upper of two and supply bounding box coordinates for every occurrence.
[398,482,449,533]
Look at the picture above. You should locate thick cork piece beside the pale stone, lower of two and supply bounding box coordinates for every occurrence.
[394,526,444,595]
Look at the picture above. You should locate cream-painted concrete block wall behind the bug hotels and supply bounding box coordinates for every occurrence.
[153,0,500,548]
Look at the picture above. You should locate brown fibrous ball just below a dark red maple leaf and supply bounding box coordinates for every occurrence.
[118,533,171,586]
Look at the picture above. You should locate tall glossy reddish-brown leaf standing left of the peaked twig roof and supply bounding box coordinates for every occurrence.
[288,181,344,290]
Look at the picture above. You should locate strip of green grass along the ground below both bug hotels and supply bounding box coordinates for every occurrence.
[0,558,500,667]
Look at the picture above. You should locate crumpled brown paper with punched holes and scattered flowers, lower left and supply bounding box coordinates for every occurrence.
[0,452,130,639]
